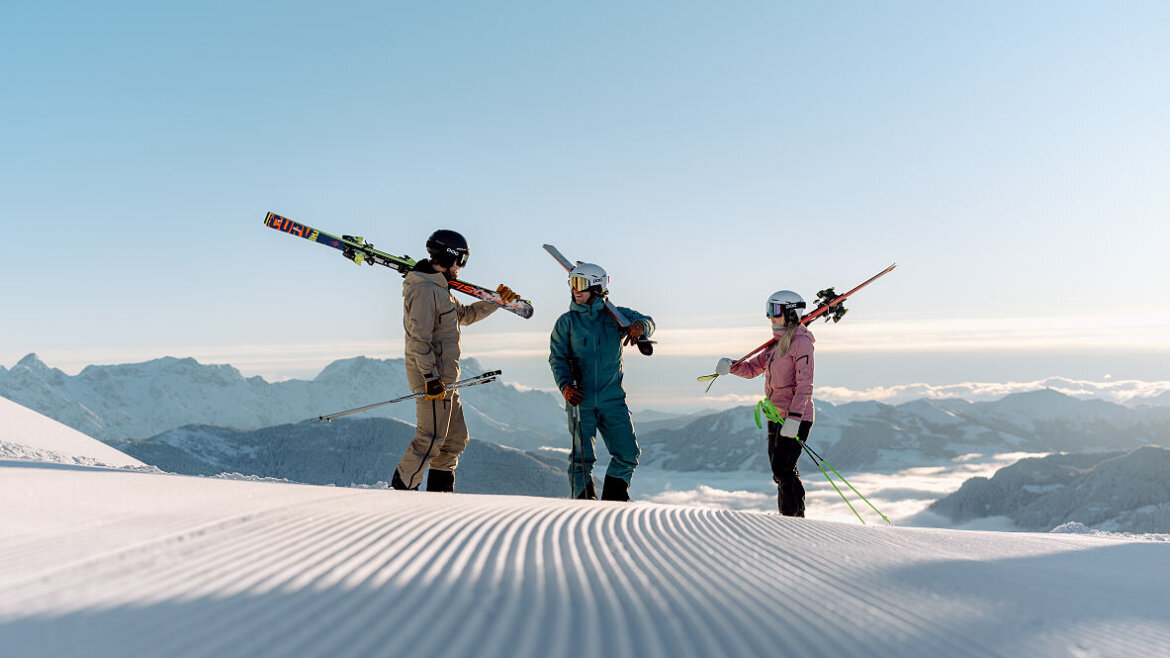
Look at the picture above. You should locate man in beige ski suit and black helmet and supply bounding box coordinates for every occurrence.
[391,229,519,492]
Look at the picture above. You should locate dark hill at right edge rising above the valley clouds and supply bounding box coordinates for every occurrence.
[930,446,1170,533]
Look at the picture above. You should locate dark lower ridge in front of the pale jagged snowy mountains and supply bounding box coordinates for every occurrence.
[106,418,569,496]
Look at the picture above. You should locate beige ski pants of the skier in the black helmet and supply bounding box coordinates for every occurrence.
[398,391,470,489]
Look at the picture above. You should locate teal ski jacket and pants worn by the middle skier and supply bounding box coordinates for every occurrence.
[549,297,654,498]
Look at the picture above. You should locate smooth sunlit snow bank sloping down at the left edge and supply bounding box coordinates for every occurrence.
[0,397,146,466]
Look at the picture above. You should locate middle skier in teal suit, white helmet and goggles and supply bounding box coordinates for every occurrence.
[549,263,654,500]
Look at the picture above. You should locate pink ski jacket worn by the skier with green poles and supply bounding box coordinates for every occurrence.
[731,324,817,423]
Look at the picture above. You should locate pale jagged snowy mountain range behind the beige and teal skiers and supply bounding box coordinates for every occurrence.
[0,354,567,450]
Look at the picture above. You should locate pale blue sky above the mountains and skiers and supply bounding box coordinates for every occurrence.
[0,1,1170,409]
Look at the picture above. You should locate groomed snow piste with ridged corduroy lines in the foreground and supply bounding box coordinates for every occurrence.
[0,463,1170,658]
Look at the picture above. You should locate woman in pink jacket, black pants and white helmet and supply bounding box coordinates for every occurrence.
[715,290,815,516]
